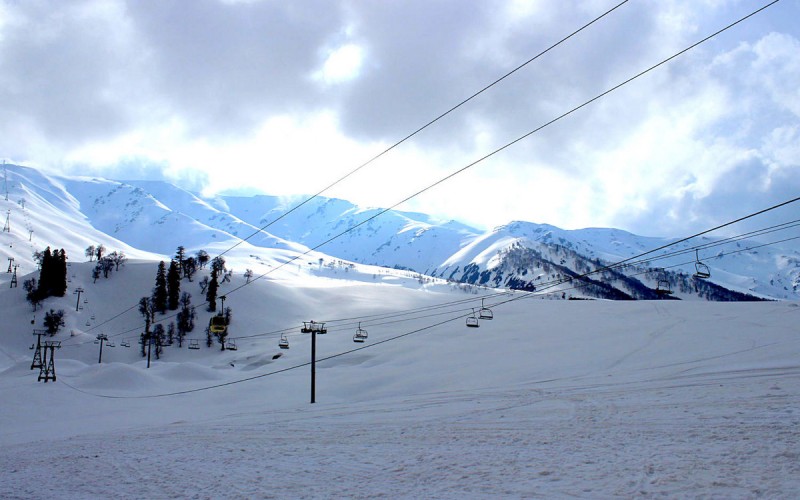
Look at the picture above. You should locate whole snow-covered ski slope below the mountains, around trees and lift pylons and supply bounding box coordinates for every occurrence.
[0,249,800,499]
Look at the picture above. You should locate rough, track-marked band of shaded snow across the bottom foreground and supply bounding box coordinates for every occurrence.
[0,367,800,498]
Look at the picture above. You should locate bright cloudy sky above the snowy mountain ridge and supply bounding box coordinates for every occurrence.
[0,0,800,236]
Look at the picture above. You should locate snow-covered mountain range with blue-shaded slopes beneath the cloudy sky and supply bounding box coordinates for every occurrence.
[0,165,800,300]
